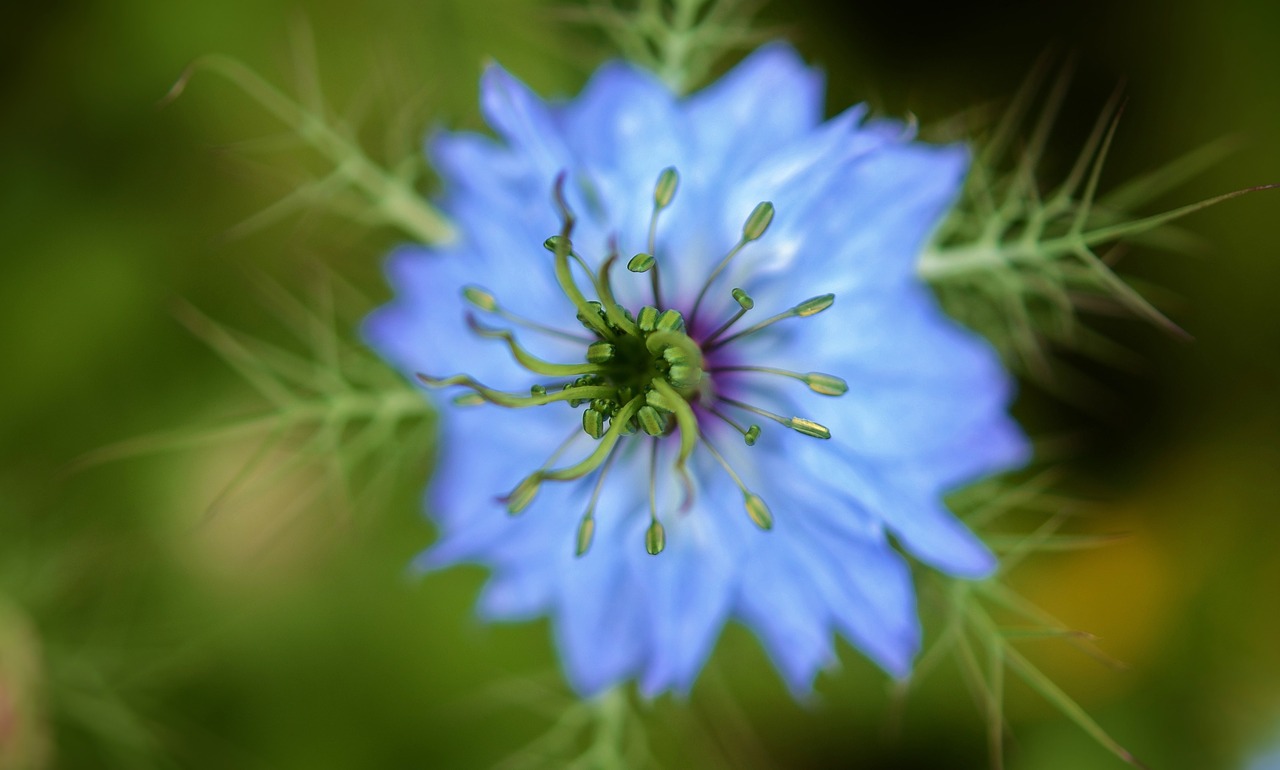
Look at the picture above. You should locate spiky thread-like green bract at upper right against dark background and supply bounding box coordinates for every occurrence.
[919,58,1267,395]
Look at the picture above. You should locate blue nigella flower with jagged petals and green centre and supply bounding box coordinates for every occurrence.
[365,45,1025,695]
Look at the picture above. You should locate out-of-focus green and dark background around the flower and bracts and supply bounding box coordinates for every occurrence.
[0,0,1280,770]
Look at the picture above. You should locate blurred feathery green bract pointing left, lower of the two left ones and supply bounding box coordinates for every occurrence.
[83,276,434,524]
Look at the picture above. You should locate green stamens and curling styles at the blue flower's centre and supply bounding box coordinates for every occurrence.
[417,169,847,555]
